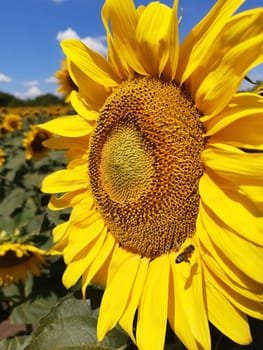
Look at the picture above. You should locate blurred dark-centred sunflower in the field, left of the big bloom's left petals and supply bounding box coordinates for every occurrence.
[23,125,52,160]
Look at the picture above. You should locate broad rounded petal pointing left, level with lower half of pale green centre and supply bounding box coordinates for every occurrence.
[42,165,89,193]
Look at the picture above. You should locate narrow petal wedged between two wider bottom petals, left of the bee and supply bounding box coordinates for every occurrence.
[119,258,149,344]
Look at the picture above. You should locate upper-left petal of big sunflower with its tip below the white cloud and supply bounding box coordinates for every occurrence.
[61,39,120,87]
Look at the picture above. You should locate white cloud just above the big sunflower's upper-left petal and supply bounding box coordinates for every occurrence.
[57,27,107,56]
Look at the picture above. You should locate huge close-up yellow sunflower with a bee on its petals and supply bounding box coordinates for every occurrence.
[39,0,263,350]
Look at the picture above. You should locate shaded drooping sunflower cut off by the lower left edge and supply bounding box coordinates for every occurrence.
[0,242,47,287]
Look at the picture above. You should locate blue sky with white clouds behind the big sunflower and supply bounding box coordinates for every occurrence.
[0,0,263,98]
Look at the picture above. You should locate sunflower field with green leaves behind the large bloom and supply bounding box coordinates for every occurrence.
[0,98,262,350]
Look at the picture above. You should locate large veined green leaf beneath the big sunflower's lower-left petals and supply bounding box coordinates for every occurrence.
[27,296,128,350]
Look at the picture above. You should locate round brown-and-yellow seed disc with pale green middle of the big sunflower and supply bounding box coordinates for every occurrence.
[89,77,205,258]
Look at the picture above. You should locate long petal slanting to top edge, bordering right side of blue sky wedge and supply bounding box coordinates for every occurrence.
[176,0,245,84]
